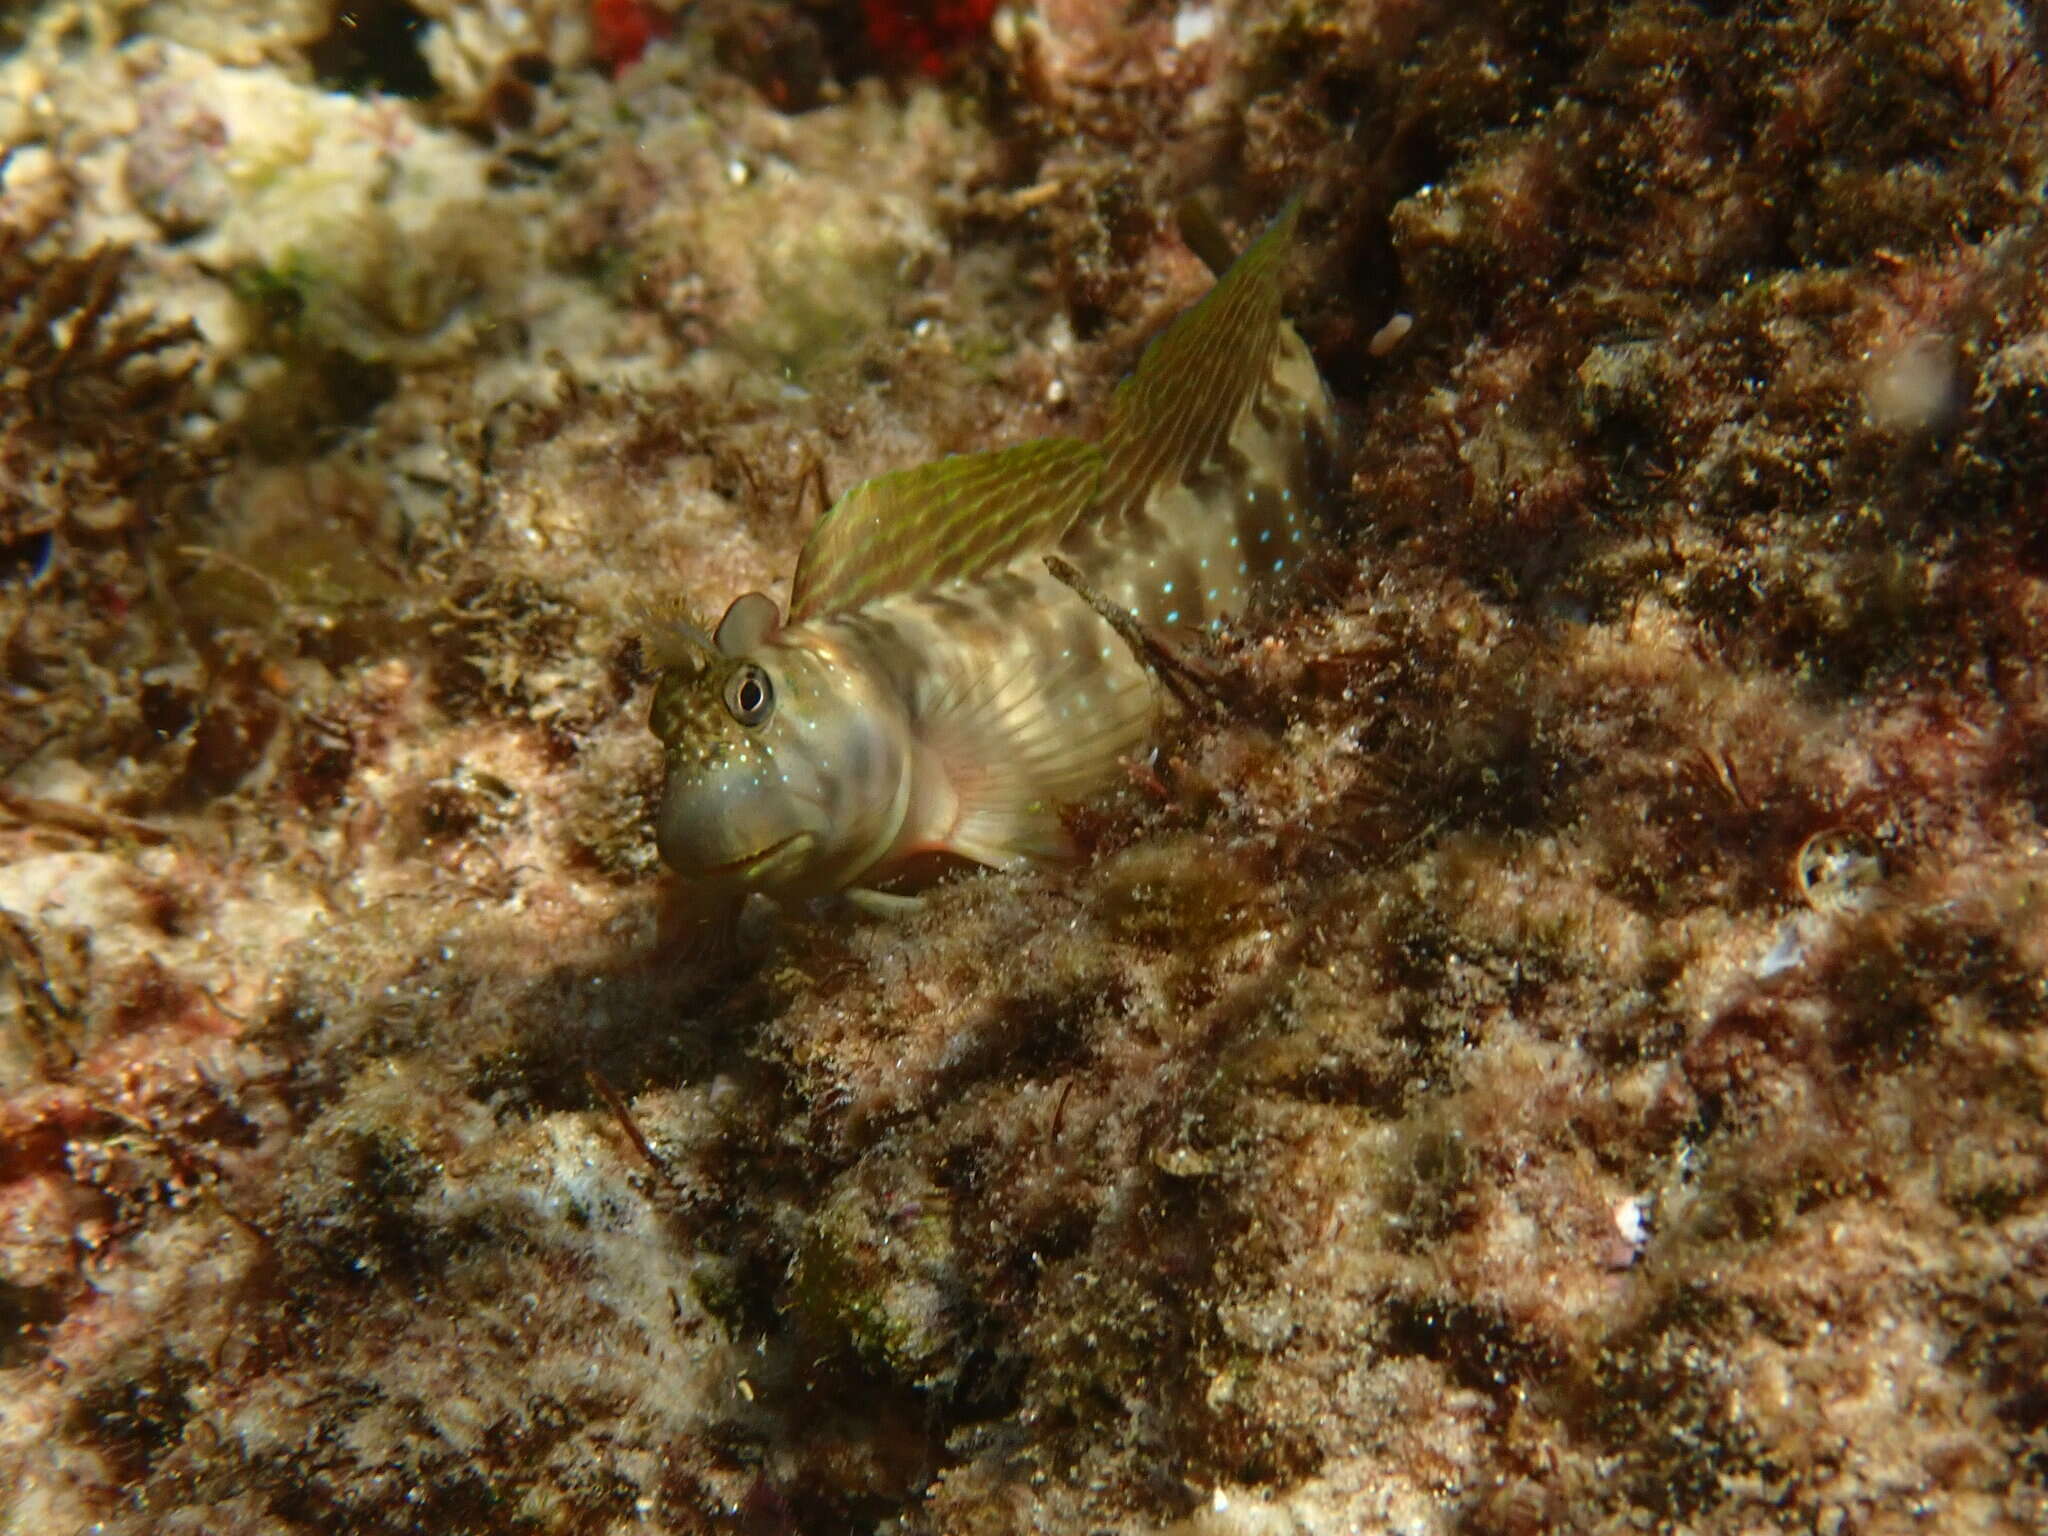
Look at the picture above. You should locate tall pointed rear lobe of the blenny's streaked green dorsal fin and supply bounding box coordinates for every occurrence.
[1100,197,1300,522]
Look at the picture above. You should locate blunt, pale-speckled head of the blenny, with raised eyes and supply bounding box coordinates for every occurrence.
[649,592,909,903]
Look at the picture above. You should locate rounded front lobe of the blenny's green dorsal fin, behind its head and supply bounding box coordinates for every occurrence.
[788,438,1102,623]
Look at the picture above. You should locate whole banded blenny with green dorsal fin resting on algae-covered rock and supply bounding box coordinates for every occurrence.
[649,199,1335,907]
